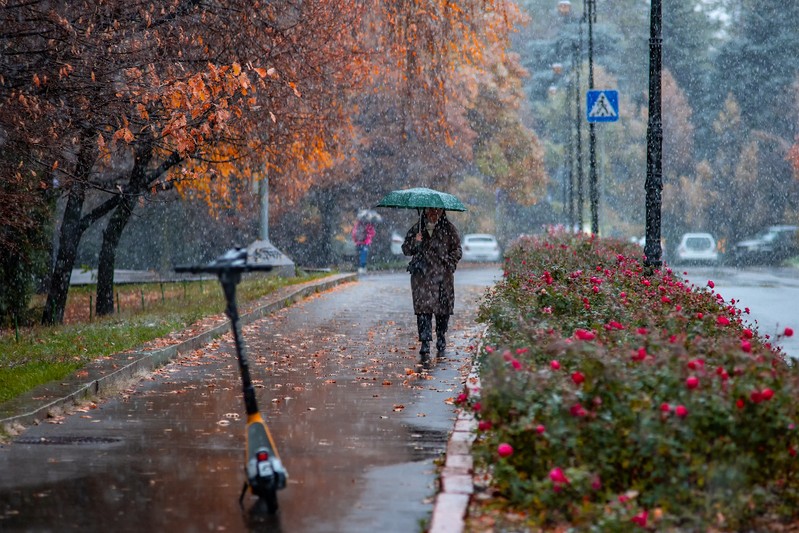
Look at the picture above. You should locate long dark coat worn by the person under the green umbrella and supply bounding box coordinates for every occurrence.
[402,214,463,315]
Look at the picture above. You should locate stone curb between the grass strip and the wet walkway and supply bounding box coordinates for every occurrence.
[0,273,358,427]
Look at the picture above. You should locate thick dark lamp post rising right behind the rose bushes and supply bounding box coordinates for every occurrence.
[644,0,663,268]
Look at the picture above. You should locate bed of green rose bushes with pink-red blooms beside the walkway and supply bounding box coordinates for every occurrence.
[468,229,799,531]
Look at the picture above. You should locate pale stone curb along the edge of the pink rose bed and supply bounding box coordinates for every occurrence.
[427,332,485,533]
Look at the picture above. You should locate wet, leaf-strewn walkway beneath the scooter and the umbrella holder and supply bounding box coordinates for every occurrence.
[0,266,500,532]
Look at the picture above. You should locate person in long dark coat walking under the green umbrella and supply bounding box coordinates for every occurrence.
[402,208,463,361]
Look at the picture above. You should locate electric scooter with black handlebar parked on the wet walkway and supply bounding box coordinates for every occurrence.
[175,248,288,513]
